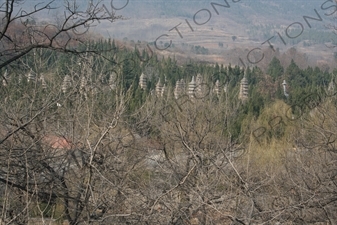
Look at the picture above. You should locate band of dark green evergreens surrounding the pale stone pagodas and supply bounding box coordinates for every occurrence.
[2,39,337,138]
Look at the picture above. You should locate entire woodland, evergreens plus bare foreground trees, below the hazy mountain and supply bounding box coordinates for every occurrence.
[0,39,337,224]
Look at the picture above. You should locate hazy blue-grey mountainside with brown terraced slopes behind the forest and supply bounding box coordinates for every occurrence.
[24,0,337,68]
